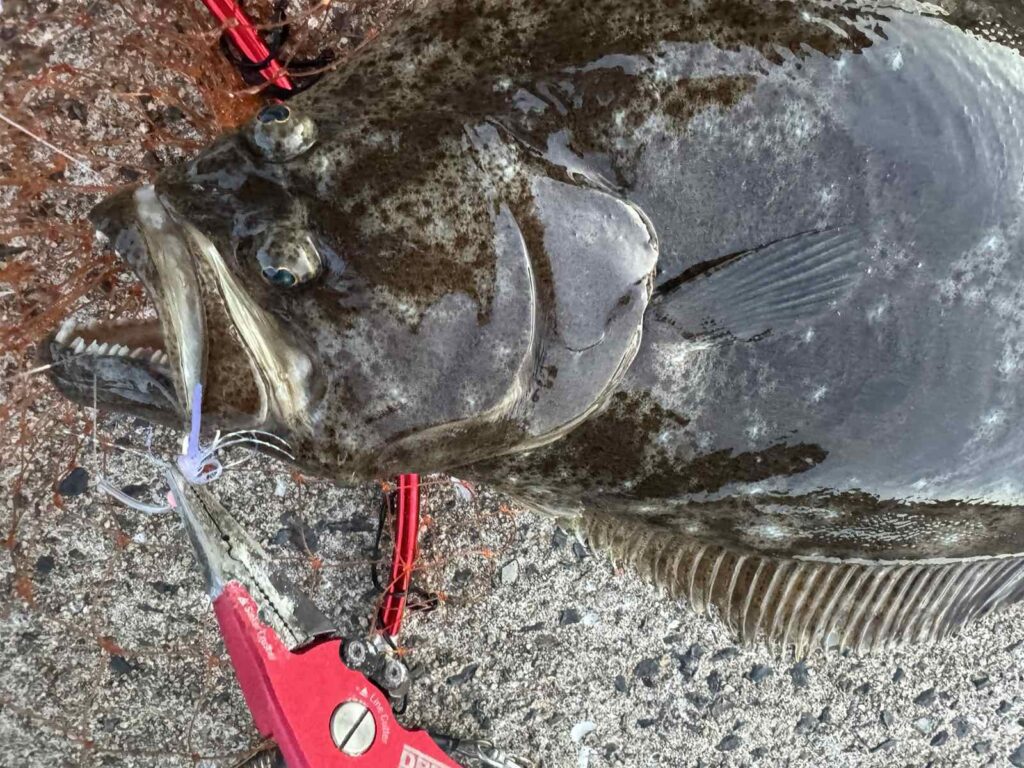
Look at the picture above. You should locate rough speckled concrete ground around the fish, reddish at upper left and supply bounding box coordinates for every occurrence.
[6,0,1024,768]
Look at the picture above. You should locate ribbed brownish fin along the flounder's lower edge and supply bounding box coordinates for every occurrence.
[578,513,1024,658]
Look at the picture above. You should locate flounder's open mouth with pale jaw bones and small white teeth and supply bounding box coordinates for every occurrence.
[40,180,325,433]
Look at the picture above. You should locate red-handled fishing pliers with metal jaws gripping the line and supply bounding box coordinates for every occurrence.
[167,466,460,768]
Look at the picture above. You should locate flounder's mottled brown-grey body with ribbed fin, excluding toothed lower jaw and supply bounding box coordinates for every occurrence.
[48,0,1024,650]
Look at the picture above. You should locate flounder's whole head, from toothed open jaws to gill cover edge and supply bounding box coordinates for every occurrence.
[43,94,656,479]
